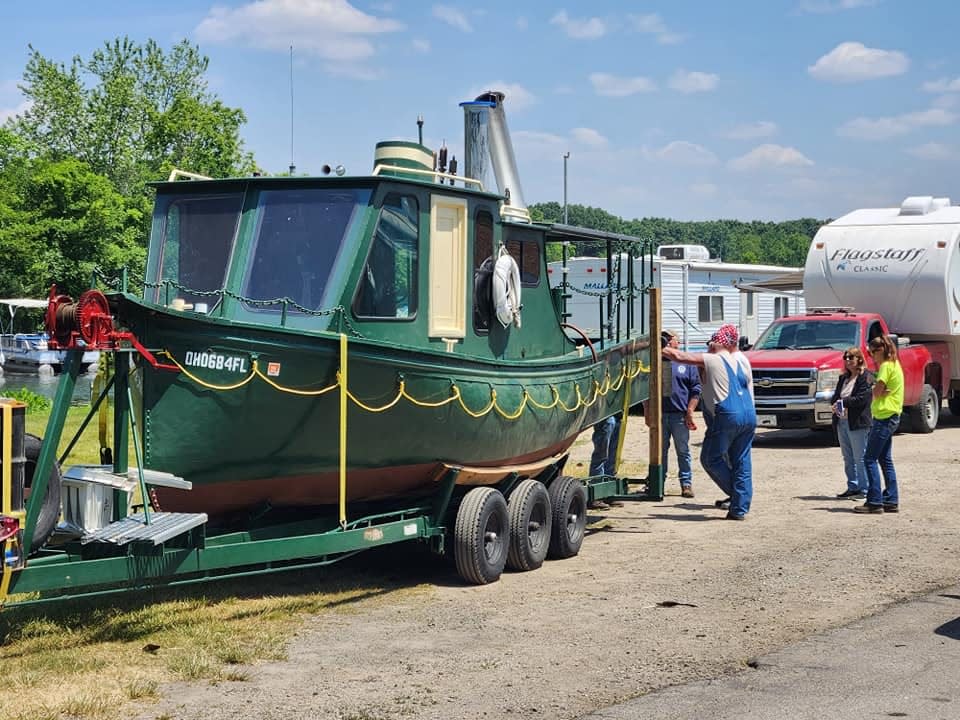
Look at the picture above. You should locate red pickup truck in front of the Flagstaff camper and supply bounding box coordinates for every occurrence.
[747,308,948,433]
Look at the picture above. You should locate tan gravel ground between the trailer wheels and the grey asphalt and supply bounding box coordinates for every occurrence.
[141,414,960,720]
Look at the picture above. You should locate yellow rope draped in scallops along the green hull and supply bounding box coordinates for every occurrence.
[158,350,650,420]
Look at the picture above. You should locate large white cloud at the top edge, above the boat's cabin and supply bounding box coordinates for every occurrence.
[194,0,404,63]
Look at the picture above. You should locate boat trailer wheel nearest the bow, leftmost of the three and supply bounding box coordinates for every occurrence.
[453,487,510,585]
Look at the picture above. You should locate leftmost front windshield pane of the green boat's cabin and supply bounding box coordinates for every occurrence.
[153,193,243,305]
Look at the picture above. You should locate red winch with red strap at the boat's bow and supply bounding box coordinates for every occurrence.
[44,285,180,372]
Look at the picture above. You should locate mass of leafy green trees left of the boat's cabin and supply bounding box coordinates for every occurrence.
[0,38,256,297]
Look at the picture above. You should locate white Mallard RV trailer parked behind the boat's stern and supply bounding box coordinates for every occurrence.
[547,245,806,352]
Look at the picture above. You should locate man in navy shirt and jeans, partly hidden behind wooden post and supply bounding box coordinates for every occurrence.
[643,330,702,498]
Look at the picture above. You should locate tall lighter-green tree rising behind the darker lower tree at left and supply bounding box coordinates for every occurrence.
[9,38,255,195]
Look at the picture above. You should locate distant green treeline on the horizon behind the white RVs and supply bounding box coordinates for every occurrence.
[530,202,828,267]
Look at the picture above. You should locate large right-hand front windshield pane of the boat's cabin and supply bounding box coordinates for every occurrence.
[243,188,370,312]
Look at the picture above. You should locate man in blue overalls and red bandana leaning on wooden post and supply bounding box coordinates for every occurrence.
[663,324,757,520]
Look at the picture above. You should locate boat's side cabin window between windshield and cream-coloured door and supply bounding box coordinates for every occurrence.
[353,194,420,319]
